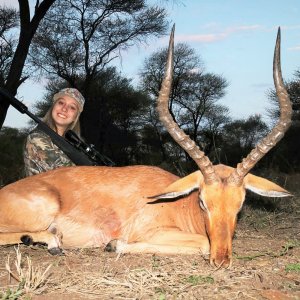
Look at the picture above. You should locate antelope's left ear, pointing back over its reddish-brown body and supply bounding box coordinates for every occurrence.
[148,171,204,203]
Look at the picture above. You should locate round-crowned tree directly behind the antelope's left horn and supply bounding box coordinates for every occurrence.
[140,43,228,170]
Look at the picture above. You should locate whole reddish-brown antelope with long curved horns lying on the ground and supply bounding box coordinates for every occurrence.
[0,27,292,268]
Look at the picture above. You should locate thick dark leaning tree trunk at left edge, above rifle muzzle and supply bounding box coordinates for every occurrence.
[0,0,55,129]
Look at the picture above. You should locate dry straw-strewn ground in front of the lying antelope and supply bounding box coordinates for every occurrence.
[0,230,300,300]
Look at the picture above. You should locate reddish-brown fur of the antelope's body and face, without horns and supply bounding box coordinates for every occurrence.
[0,165,286,265]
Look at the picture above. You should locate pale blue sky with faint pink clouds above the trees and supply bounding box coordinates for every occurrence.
[0,0,300,127]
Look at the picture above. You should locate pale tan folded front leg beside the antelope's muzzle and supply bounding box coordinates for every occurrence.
[106,230,210,254]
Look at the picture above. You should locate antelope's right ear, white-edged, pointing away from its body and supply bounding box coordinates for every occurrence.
[244,174,292,197]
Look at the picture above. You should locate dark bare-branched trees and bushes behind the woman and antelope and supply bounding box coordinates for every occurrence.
[0,0,300,186]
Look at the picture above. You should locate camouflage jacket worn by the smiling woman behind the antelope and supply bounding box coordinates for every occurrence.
[24,129,75,176]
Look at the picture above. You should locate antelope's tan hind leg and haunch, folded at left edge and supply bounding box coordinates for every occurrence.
[0,180,62,254]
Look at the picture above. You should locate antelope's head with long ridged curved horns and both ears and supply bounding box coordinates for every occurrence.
[153,27,292,267]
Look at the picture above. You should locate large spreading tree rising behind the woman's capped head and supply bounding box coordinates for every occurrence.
[31,0,167,143]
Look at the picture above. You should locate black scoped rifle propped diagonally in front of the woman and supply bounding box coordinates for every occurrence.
[0,88,114,166]
